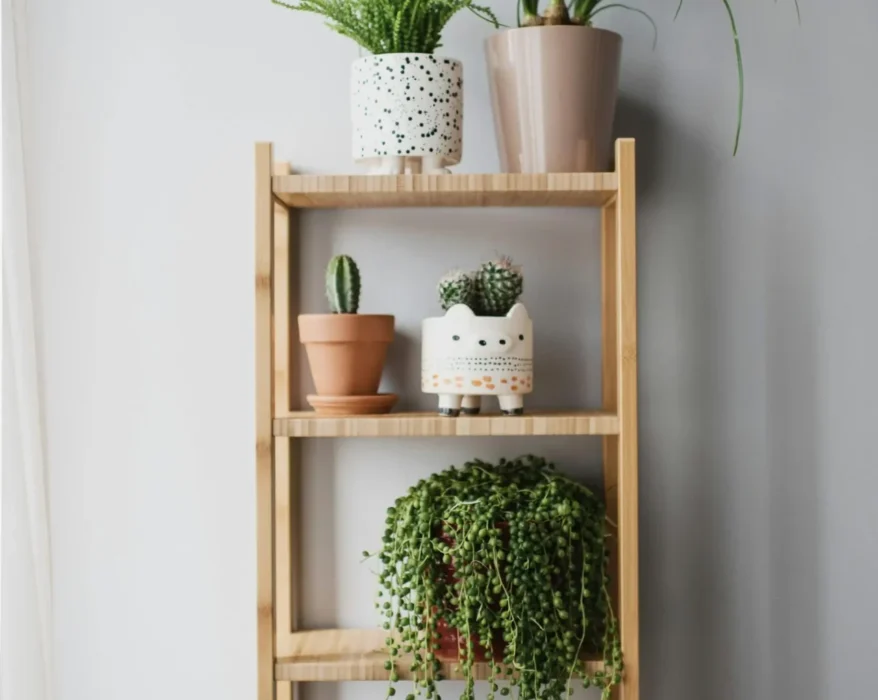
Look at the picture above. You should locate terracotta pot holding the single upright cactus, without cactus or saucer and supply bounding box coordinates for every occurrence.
[299,314,393,396]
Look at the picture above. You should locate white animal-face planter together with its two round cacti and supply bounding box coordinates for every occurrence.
[421,257,533,417]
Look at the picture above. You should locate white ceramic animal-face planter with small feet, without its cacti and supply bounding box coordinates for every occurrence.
[421,304,533,416]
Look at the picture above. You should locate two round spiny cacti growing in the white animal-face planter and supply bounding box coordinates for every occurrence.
[438,255,524,316]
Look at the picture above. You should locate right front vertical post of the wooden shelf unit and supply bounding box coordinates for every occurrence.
[615,139,640,700]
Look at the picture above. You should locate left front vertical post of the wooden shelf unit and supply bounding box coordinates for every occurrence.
[256,143,275,700]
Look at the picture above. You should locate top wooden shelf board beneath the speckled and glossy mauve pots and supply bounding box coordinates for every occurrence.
[272,173,618,208]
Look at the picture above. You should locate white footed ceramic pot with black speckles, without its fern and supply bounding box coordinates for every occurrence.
[351,53,463,173]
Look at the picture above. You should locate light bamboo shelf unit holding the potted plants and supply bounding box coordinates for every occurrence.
[255,139,640,700]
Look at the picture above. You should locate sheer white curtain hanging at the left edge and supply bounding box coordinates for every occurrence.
[0,0,52,700]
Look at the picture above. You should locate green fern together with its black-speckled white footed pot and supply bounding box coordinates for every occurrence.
[272,0,498,174]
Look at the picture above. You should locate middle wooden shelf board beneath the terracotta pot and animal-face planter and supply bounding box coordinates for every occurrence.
[274,411,619,438]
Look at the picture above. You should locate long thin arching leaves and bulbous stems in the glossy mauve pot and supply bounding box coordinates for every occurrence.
[518,0,801,154]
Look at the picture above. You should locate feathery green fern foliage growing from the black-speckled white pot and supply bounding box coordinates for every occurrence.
[271,0,500,54]
